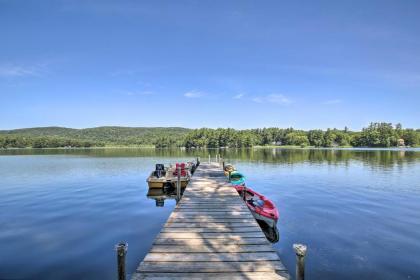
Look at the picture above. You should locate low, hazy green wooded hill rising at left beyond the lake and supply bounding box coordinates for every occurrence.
[0,126,190,146]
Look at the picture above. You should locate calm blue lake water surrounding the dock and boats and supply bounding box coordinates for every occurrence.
[0,149,420,279]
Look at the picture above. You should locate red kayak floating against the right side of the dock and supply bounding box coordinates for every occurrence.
[235,186,279,227]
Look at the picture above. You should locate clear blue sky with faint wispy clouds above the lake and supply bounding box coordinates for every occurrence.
[0,0,420,130]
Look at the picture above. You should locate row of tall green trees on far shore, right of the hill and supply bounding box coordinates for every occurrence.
[183,123,420,148]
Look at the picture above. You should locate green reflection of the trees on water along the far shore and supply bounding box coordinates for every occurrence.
[0,148,420,169]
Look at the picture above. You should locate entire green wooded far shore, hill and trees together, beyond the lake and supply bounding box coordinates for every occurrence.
[0,123,420,148]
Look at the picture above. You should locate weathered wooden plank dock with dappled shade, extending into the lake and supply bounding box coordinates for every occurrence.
[131,163,289,280]
